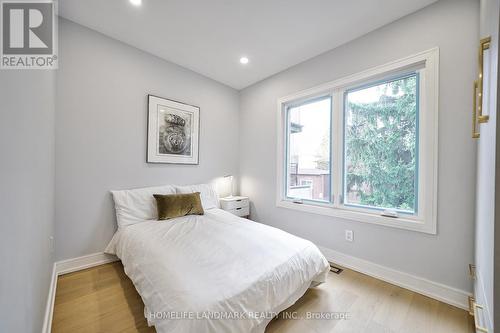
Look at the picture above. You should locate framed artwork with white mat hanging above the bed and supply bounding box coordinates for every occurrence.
[147,95,200,164]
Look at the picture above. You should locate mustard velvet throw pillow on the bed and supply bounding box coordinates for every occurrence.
[153,192,204,220]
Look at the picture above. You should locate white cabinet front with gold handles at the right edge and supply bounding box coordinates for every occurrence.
[474,0,500,331]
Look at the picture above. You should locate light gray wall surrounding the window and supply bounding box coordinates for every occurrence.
[240,0,479,291]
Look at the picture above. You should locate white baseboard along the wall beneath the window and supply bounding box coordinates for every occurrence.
[318,246,472,310]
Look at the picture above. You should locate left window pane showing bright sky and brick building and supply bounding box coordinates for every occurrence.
[286,97,332,201]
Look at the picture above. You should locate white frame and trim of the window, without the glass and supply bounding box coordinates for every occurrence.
[276,48,439,234]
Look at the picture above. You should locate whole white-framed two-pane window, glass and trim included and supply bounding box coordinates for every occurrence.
[277,49,439,233]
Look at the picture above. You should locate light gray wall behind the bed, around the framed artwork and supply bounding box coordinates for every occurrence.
[56,20,239,260]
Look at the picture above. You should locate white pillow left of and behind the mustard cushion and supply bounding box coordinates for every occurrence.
[111,185,175,227]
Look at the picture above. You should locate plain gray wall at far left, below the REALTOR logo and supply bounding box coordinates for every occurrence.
[0,70,55,333]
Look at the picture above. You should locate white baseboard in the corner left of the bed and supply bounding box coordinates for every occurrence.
[42,252,119,333]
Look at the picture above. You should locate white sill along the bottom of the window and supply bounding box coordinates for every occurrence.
[276,200,437,235]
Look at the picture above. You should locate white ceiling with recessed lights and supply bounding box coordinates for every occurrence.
[59,0,437,89]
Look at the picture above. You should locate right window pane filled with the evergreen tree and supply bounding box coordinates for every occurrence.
[344,74,418,213]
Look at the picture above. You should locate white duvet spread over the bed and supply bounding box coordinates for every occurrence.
[106,209,329,333]
